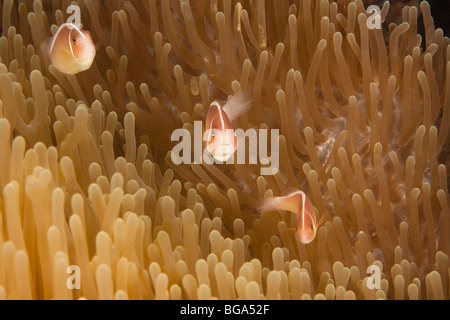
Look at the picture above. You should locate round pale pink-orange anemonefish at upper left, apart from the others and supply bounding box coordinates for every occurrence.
[49,23,96,74]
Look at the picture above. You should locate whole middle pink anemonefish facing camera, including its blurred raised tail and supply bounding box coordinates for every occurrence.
[205,91,252,162]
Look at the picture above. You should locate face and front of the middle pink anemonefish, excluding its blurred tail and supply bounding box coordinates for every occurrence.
[206,102,237,162]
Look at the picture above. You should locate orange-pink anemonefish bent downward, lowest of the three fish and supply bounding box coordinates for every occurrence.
[258,190,317,244]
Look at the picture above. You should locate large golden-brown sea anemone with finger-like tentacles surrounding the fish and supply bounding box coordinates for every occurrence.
[0,0,450,299]
